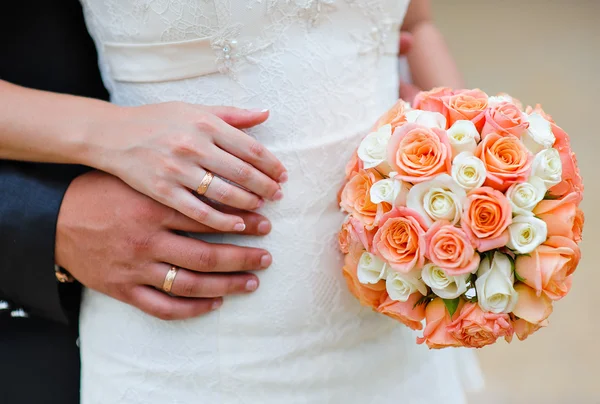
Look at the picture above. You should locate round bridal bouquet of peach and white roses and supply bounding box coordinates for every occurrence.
[339,88,584,348]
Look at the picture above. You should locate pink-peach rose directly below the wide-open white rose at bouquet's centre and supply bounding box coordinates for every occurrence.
[425,221,480,276]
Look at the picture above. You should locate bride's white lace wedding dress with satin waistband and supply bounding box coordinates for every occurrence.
[80,0,480,404]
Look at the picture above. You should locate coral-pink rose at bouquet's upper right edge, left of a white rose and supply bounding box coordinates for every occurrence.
[481,102,529,138]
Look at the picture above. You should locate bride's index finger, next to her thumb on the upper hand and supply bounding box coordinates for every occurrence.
[214,120,288,183]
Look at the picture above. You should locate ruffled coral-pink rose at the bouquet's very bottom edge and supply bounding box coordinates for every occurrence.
[448,303,514,348]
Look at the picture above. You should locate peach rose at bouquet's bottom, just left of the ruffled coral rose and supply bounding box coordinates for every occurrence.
[417,298,464,349]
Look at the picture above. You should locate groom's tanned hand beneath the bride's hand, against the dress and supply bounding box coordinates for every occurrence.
[56,172,271,320]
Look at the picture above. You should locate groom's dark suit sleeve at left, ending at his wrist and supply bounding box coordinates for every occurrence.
[0,160,82,323]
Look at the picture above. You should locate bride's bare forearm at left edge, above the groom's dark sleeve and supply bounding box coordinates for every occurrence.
[0,80,118,166]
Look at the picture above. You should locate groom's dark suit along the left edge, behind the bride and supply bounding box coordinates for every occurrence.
[0,0,107,404]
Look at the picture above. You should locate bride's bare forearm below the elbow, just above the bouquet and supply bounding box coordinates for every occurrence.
[408,21,464,89]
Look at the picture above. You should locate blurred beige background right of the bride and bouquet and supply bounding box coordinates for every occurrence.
[432,0,600,404]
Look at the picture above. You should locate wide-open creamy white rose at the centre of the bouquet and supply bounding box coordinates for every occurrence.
[406,174,467,225]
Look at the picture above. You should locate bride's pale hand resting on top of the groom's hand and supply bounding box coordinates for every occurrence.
[90,102,287,231]
